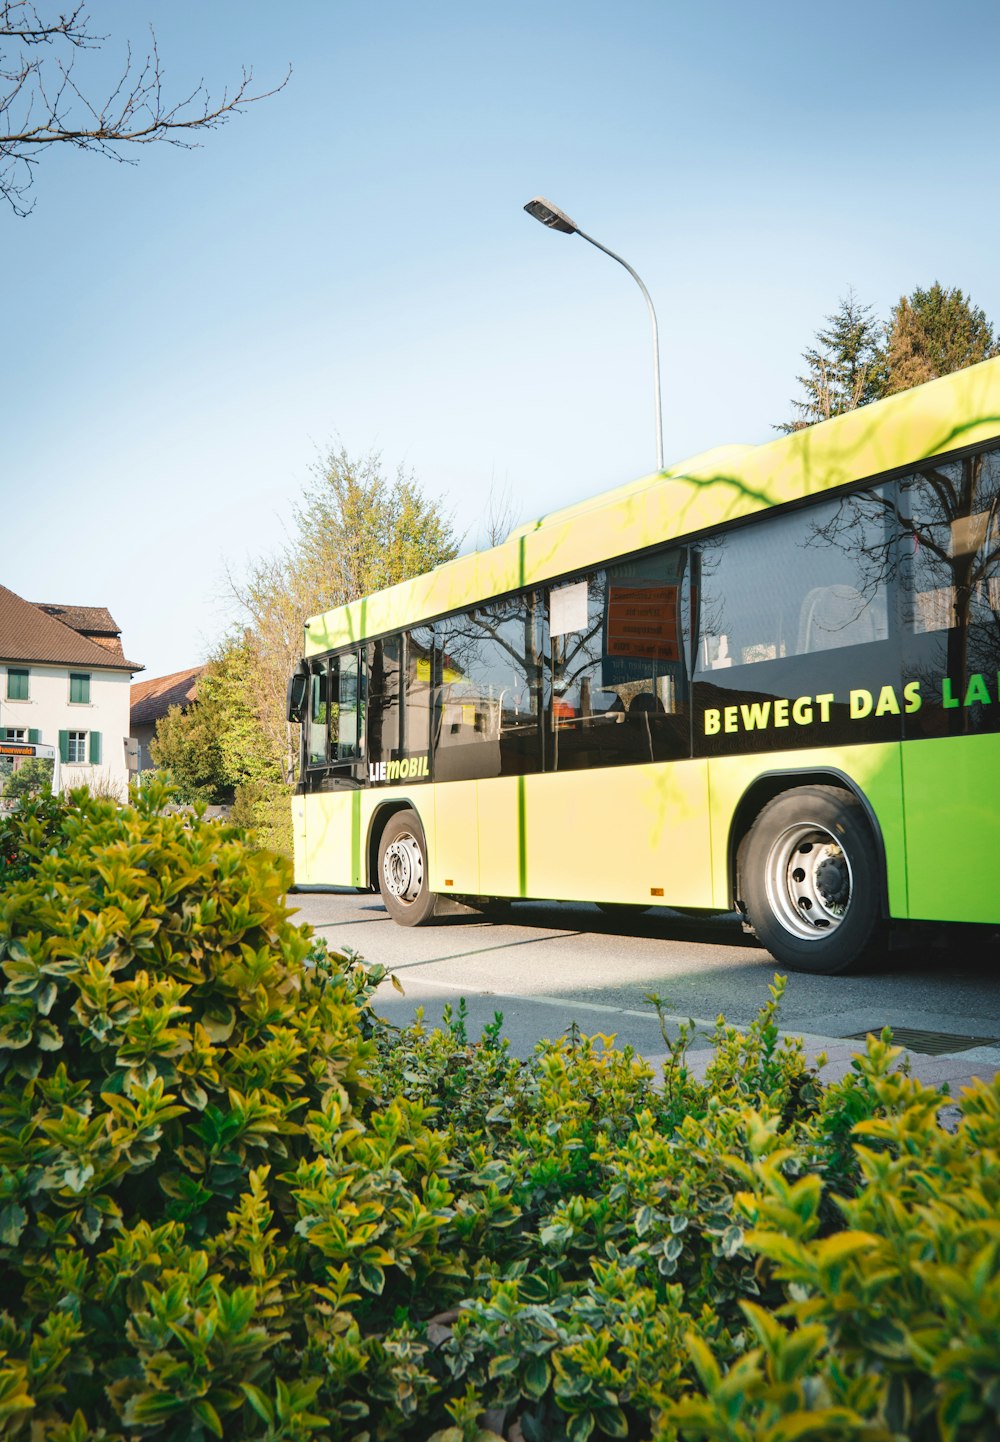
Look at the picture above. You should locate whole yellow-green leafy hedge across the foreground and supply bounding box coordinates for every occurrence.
[0,787,1000,1442]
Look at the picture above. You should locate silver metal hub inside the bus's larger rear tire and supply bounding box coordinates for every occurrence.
[765,822,853,942]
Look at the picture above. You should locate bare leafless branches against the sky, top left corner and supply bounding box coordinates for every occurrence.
[0,0,287,216]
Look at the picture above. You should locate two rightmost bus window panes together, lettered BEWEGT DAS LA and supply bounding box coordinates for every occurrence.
[693,446,1000,757]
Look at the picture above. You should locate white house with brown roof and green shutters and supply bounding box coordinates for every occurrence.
[0,585,143,797]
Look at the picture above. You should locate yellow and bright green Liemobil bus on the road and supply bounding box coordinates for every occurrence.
[289,359,1000,973]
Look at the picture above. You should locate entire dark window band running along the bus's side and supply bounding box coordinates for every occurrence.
[300,432,1000,782]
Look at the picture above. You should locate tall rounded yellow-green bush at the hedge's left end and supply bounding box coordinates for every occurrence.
[0,786,453,1438]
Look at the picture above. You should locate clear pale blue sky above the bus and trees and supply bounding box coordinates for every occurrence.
[0,0,1000,676]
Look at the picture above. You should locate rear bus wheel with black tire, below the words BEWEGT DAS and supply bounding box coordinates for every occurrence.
[742,786,882,976]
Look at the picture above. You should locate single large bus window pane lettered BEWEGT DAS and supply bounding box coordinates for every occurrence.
[693,485,903,756]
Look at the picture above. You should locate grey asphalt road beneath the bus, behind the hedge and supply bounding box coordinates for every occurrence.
[289,891,1000,1082]
